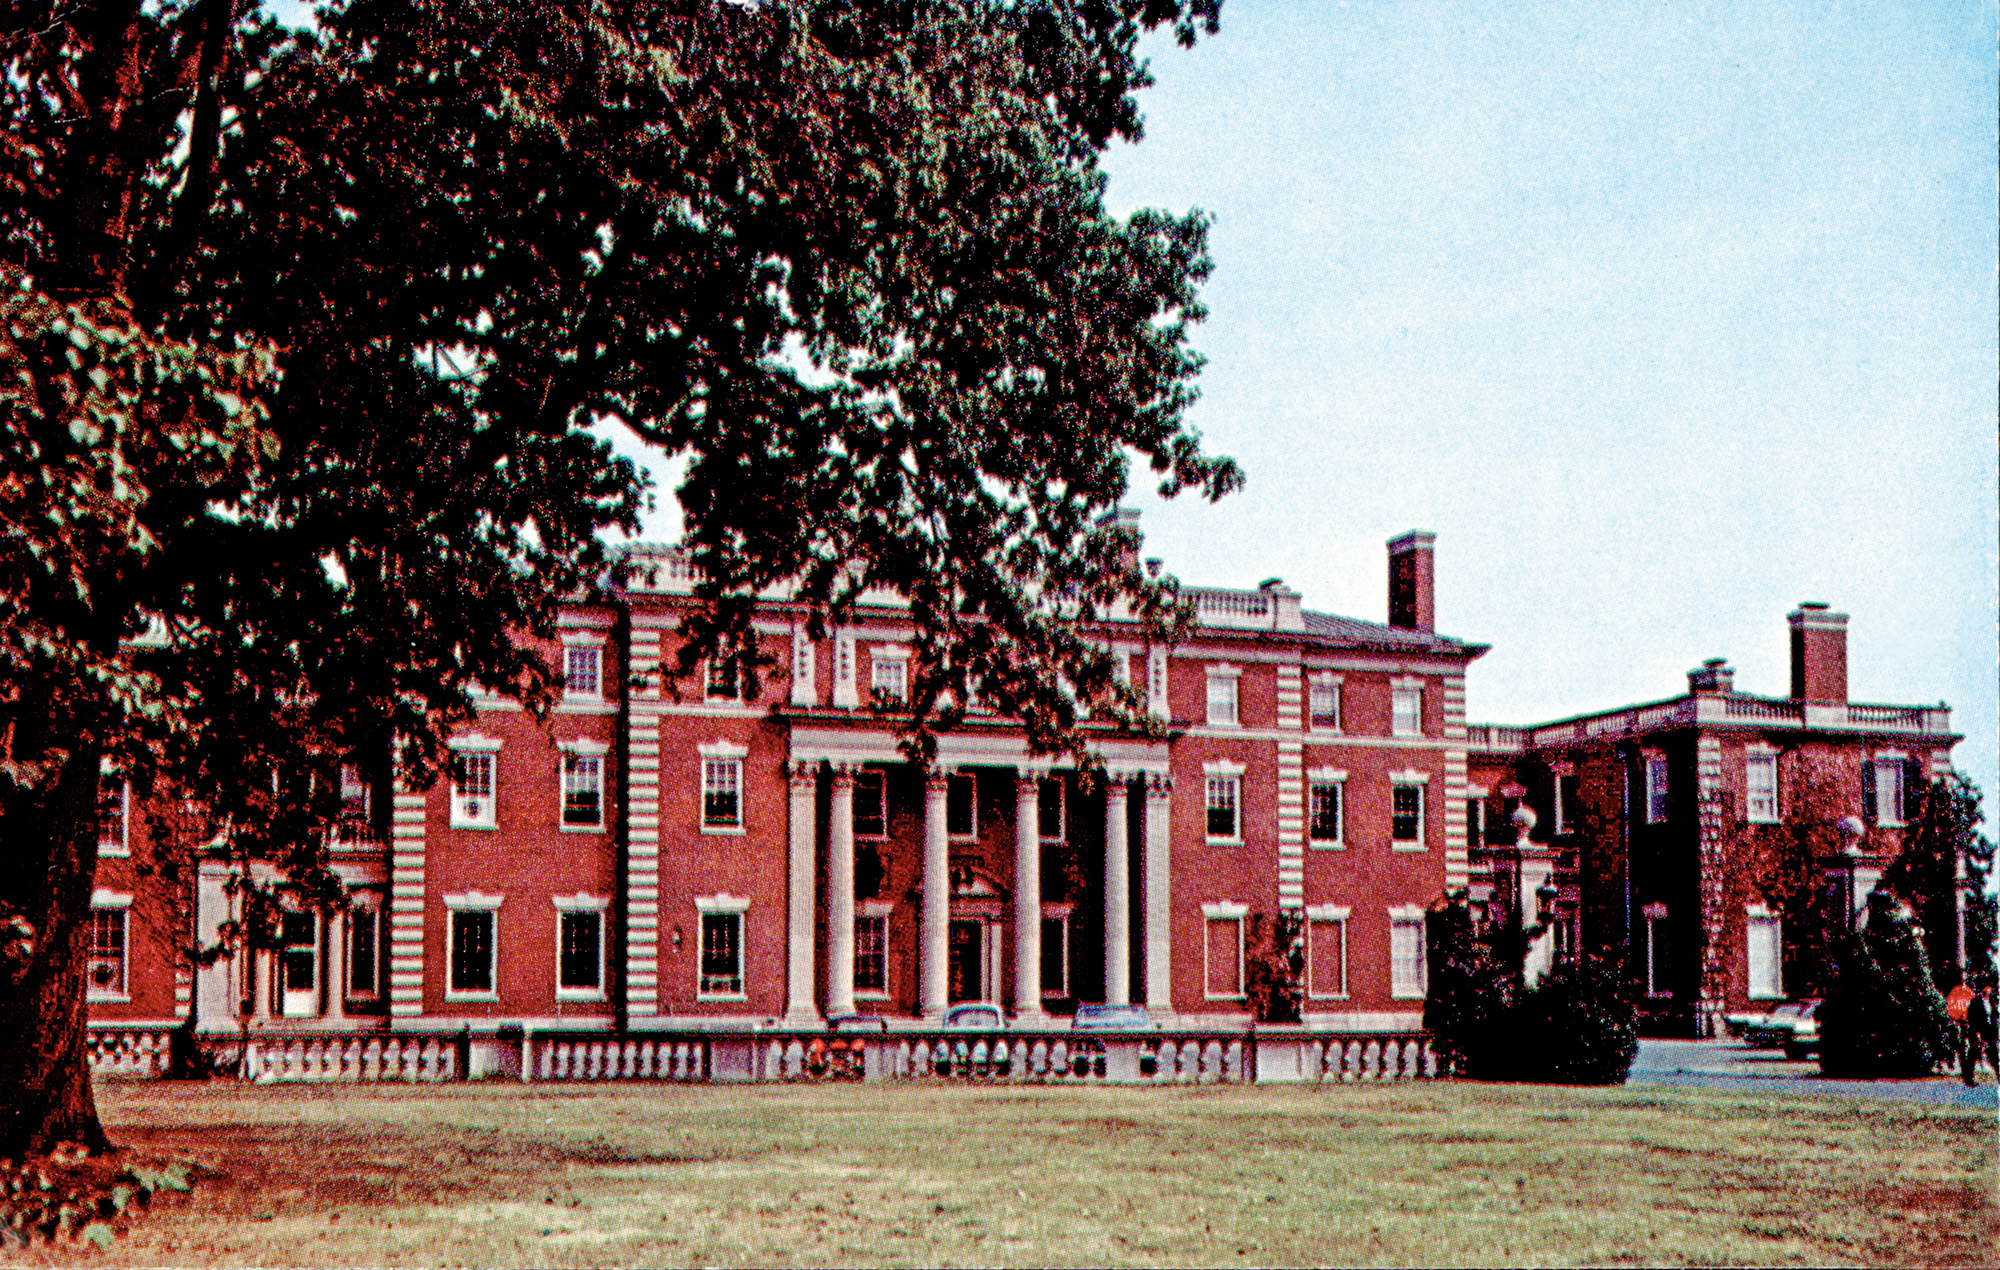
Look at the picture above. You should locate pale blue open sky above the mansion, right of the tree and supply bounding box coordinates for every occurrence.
[1106,0,2000,808]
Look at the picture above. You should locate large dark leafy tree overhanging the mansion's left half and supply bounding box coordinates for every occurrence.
[0,0,1238,1152]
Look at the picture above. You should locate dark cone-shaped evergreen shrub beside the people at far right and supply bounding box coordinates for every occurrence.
[1818,890,1958,1080]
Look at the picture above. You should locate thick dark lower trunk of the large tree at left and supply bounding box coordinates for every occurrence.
[0,746,110,1160]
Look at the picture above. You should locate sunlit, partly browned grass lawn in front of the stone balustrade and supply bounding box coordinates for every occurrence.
[47,1082,2000,1266]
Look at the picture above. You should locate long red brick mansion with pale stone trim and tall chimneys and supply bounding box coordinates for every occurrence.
[90,532,1958,1078]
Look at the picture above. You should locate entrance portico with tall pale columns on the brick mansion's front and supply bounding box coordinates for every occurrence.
[786,728,1170,1024]
